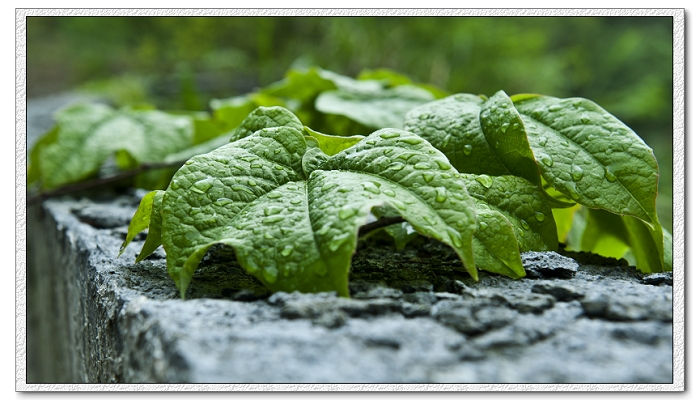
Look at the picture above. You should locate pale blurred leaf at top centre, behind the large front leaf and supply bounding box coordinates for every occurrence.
[316,85,434,129]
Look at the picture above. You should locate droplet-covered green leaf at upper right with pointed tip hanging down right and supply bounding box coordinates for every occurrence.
[515,95,660,228]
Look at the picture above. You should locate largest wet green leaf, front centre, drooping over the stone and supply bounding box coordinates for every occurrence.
[157,122,477,296]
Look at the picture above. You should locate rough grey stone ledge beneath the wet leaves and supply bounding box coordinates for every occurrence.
[27,192,673,383]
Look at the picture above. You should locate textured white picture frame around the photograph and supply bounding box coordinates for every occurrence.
[15,9,685,391]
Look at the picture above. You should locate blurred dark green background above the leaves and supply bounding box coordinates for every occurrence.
[27,17,673,230]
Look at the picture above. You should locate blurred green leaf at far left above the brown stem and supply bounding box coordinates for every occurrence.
[32,104,193,188]
